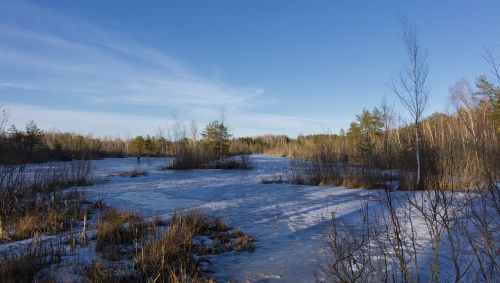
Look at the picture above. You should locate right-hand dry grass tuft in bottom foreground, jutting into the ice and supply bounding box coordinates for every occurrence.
[136,210,254,282]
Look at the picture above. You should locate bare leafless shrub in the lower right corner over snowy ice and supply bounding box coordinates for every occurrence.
[322,181,500,282]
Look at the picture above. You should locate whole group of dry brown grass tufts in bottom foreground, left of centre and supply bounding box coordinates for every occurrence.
[85,209,254,282]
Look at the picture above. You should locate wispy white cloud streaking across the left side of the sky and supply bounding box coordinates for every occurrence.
[0,0,336,138]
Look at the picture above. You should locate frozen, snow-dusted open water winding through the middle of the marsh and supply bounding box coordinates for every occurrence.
[87,156,373,282]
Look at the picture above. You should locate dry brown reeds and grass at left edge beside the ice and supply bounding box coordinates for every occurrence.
[0,161,93,242]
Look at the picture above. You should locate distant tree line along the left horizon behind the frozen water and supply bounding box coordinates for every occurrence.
[0,108,290,164]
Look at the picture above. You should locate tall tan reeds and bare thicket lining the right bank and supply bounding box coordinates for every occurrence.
[275,87,500,192]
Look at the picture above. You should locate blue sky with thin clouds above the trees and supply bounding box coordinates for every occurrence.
[0,0,500,137]
